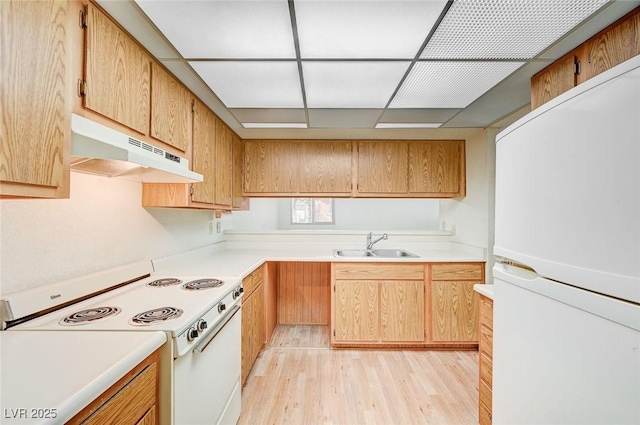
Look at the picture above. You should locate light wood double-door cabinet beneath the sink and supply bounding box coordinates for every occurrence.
[331,263,425,346]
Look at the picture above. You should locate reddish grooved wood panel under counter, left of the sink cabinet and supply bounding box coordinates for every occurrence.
[278,262,331,325]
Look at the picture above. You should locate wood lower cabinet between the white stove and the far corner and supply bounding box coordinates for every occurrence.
[241,266,266,385]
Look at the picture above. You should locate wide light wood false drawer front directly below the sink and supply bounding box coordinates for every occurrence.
[334,263,424,280]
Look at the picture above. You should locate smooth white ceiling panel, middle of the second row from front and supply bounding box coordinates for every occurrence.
[302,61,410,108]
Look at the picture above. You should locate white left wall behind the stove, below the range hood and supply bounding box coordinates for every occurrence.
[0,172,222,295]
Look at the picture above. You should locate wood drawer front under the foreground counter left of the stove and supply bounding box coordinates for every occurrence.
[83,363,157,424]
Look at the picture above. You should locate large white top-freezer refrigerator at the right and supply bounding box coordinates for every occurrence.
[493,56,640,425]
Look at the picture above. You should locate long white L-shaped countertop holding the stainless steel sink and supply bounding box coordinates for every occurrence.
[153,247,485,277]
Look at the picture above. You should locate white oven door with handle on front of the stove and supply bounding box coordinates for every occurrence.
[174,305,242,425]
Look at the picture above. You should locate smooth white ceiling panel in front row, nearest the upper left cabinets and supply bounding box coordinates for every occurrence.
[136,0,296,59]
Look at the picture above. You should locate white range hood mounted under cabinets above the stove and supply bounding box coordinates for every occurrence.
[71,114,203,183]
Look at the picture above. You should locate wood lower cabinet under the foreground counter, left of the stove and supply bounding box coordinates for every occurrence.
[67,351,159,425]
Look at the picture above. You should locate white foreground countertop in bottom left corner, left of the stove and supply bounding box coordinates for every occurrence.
[0,330,166,424]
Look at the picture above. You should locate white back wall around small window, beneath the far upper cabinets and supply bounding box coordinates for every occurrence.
[230,198,439,231]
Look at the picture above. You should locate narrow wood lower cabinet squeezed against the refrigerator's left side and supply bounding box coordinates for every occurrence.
[478,295,493,425]
